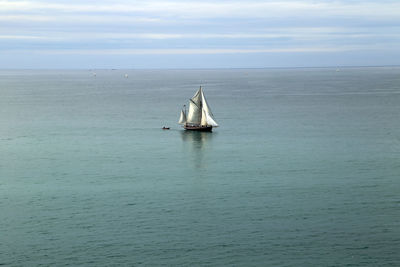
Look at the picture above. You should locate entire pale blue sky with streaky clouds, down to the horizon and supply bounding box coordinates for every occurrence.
[0,0,400,68]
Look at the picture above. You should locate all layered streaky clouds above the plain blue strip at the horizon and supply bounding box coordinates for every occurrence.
[0,0,400,67]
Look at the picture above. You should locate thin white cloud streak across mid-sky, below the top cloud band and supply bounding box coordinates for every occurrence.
[0,27,400,42]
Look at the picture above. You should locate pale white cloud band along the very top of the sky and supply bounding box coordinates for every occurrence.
[0,1,400,19]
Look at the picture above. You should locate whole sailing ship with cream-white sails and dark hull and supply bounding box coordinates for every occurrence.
[178,86,218,132]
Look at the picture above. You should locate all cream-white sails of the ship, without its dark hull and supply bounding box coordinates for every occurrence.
[179,86,218,127]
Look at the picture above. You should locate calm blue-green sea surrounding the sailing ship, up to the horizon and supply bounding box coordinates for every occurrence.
[0,67,400,266]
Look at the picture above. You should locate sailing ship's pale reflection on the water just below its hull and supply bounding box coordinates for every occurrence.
[181,131,215,169]
